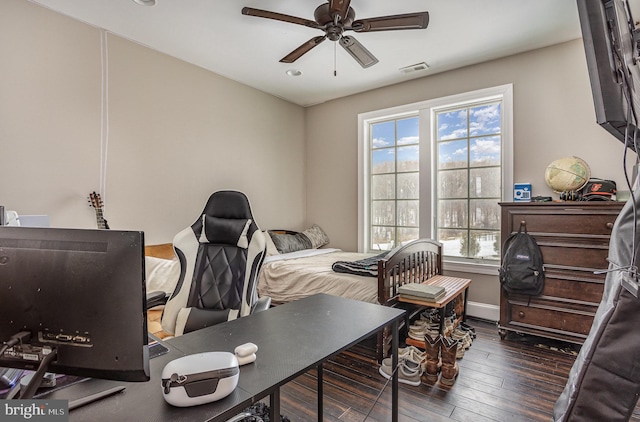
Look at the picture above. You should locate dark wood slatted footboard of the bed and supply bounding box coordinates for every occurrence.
[377,239,442,362]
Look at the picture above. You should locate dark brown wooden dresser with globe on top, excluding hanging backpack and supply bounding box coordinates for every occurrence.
[499,201,624,344]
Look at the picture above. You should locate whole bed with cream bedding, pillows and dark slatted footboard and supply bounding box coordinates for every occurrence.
[145,237,442,360]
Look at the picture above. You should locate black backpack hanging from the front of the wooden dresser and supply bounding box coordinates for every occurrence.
[499,225,544,296]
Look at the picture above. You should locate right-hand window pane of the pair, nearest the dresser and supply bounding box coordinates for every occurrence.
[433,100,502,260]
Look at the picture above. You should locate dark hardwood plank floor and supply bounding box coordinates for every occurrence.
[272,319,640,422]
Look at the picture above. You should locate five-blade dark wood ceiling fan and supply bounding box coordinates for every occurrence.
[242,0,429,68]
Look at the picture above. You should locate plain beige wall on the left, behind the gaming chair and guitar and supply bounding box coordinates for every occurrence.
[0,0,305,244]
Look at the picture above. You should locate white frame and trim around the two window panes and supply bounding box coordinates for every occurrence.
[358,84,513,275]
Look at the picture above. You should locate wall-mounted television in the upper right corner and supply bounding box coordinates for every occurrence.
[577,0,640,151]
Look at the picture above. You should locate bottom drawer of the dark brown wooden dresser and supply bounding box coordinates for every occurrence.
[501,303,597,337]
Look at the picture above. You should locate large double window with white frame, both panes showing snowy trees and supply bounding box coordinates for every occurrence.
[358,85,513,274]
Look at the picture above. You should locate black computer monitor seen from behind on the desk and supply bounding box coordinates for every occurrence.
[0,226,149,394]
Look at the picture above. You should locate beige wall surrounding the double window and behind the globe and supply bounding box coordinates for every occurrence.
[306,40,636,305]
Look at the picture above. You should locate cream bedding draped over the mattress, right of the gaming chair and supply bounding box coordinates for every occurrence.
[258,249,378,303]
